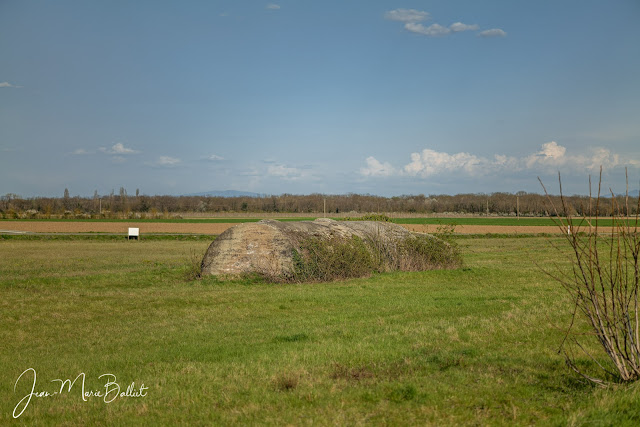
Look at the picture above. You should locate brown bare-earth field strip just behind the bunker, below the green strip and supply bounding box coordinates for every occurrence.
[0,221,609,235]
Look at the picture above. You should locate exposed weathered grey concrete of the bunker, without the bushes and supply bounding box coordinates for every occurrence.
[202,218,412,276]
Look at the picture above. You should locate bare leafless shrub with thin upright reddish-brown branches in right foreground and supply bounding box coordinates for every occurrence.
[538,168,640,386]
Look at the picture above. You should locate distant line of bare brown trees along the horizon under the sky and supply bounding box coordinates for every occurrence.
[0,188,638,218]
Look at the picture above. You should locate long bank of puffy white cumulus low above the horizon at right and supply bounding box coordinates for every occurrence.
[360,141,640,178]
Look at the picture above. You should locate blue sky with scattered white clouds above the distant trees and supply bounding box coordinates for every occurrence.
[0,0,640,197]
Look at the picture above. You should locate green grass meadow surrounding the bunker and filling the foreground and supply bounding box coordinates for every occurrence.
[0,237,640,426]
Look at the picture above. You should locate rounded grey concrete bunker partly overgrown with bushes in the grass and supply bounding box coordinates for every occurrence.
[201,218,461,281]
